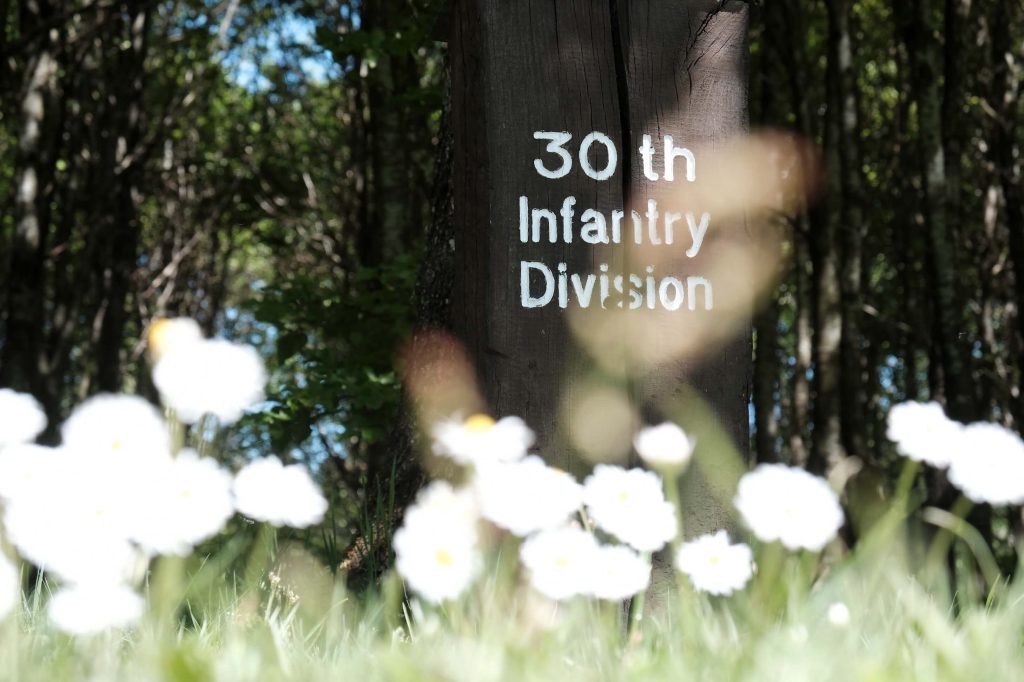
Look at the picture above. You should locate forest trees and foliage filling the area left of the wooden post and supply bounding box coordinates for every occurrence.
[0,0,443,545]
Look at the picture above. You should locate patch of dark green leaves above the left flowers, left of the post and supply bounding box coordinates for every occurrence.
[254,254,416,455]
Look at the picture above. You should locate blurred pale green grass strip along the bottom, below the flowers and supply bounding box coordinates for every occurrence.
[0,518,1024,682]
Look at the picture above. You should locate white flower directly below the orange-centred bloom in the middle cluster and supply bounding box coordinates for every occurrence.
[473,456,583,537]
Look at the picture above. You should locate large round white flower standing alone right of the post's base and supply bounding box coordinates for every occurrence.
[733,464,843,551]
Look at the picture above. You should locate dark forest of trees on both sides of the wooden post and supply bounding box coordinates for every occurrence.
[0,0,1024,569]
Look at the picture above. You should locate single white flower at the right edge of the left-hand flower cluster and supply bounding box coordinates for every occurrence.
[233,457,327,528]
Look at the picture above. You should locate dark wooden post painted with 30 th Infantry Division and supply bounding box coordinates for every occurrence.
[452,0,751,531]
